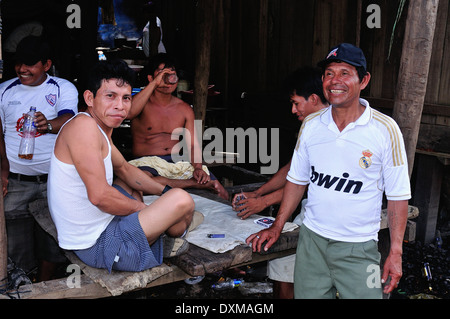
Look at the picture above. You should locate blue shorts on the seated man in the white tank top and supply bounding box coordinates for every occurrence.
[74,185,163,272]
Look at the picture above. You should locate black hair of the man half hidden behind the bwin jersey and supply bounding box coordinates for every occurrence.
[283,66,328,103]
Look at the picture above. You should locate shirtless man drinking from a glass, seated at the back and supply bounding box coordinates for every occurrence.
[128,53,228,199]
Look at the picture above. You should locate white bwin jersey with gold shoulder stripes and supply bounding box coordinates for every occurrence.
[287,99,411,242]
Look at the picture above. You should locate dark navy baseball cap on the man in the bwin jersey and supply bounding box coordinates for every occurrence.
[317,43,367,71]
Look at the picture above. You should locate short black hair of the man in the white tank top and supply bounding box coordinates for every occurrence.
[87,59,136,97]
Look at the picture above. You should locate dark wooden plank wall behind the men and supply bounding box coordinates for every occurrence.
[154,0,450,155]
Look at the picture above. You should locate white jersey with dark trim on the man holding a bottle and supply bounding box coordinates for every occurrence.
[0,75,78,176]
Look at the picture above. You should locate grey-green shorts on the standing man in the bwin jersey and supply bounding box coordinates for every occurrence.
[294,225,383,299]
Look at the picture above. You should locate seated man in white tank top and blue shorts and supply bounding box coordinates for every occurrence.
[48,60,194,271]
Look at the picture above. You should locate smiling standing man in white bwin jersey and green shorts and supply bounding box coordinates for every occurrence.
[247,43,411,298]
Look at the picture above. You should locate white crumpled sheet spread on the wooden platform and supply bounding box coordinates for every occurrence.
[144,194,298,253]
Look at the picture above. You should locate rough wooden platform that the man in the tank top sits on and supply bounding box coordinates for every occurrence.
[0,191,298,299]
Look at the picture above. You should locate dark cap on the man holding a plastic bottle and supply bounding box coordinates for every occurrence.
[14,35,51,65]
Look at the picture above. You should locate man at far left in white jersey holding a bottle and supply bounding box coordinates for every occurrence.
[0,36,78,279]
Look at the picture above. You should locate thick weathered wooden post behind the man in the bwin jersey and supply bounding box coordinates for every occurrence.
[393,0,439,176]
